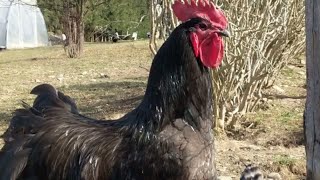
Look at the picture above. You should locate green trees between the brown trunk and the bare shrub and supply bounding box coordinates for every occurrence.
[84,0,150,41]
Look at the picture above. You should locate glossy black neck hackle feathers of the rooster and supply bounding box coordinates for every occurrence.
[127,18,212,131]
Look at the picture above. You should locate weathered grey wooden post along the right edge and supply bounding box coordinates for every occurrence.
[304,0,320,180]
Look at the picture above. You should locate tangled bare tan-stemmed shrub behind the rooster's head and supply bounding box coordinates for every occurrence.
[150,0,305,130]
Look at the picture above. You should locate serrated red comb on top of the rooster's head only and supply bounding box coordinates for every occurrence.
[172,0,228,29]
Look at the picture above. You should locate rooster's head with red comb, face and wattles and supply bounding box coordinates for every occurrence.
[172,0,229,68]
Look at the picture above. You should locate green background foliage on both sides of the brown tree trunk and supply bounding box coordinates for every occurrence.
[38,0,150,39]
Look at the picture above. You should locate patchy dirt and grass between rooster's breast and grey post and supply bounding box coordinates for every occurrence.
[216,63,306,180]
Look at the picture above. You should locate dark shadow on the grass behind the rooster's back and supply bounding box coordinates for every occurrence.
[62,81,146,119]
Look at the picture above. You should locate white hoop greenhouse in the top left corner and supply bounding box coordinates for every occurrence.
[0,0,48,49]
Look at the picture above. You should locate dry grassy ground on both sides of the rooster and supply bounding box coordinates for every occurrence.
[0,41,305,179]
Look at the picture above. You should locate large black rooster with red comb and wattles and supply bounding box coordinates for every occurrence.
[0,0,228,180]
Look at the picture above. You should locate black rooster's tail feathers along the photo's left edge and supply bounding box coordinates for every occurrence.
[0,84,81,180]
